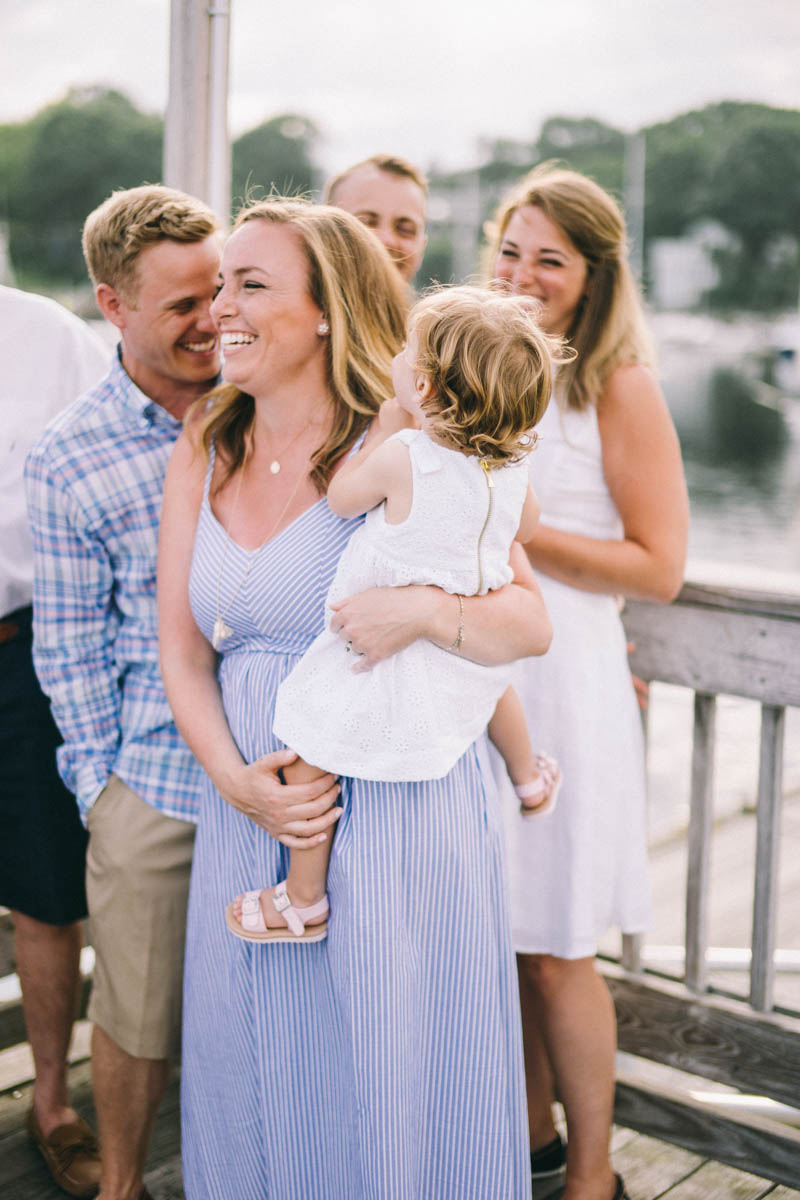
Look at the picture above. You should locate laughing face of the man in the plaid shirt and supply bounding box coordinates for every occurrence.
[103,235,219,415]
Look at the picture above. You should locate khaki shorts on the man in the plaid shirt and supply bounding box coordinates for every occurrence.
[86,775,194,1058]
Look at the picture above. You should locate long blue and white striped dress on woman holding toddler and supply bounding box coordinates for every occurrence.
[182,453,530,1200]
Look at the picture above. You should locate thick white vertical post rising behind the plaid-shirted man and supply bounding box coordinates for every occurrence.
[164,0,230,224]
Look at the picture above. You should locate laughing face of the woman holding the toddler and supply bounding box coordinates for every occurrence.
[211,220,327,398]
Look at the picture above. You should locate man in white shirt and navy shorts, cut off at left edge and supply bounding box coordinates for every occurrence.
[0,278,110,1196]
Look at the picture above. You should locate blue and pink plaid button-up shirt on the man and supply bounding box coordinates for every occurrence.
[25,356,200,821]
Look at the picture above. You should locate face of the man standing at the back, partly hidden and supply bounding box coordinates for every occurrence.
[331,164,428,283]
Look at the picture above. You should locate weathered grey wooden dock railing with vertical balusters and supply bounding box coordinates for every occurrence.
[603,568,800,1188]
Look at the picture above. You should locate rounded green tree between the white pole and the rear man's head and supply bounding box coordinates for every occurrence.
[231,113,319,211]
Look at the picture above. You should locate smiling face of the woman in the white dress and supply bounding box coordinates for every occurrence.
[493,204,589,336]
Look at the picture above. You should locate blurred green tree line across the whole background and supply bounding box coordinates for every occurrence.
[0,88,800,310]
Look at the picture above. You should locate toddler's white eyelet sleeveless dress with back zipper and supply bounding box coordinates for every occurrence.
[272,430,528,781]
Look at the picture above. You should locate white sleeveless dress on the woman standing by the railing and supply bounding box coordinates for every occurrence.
[493,397,650,959]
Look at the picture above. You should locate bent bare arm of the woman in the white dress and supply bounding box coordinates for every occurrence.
[525,366,688,602]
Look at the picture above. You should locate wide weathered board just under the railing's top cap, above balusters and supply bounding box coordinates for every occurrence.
[622,600,800,706]
